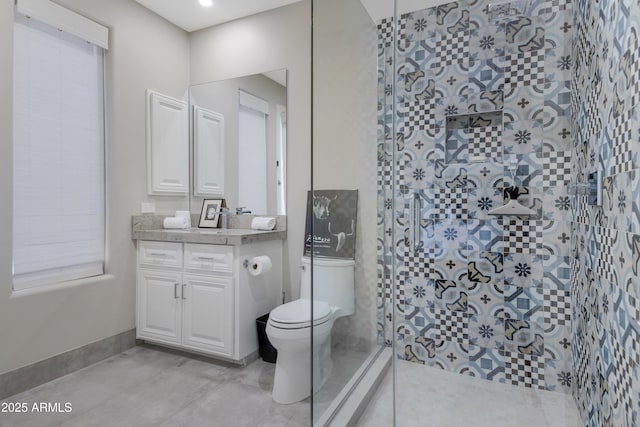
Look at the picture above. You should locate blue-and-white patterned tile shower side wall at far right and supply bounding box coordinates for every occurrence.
[571,0,640,427]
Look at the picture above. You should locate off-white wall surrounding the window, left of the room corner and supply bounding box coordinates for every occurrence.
[0,0,189,373]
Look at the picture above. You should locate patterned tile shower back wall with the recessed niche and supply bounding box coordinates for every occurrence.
[378,0,573,393]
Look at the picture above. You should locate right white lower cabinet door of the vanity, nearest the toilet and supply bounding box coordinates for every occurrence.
[182,275,234,356]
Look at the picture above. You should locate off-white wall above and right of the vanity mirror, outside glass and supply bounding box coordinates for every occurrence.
[191,1,311,299]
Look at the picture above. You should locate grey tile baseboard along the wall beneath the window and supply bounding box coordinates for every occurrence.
[0,329,136,400]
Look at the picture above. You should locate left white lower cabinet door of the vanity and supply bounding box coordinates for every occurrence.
[137,269,182,344]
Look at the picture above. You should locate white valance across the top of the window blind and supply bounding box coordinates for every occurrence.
[16,0,109,49]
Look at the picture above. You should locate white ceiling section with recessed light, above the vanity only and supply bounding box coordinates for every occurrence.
[136,0,300,32]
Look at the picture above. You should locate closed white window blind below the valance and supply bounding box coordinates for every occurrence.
[13,13,105,290]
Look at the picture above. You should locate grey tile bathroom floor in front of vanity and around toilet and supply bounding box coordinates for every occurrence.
[0,345,366,427]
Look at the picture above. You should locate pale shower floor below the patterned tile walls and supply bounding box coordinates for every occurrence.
[358,361,582,427]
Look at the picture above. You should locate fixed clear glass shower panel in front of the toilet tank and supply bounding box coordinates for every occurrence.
[306,0,391,426]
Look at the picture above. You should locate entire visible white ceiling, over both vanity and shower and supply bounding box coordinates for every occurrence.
[136,0,450,32]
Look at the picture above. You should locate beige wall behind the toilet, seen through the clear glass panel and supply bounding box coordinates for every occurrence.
[313,0,378,350]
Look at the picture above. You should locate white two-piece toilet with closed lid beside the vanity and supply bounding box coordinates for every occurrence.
[267,257,355,404]
